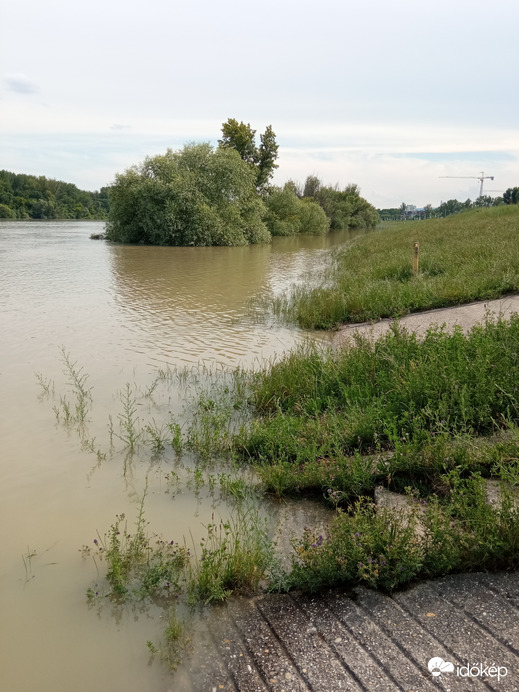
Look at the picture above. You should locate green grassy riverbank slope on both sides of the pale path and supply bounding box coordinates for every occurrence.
[234,207,519,589]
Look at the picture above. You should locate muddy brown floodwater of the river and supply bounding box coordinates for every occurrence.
[0,221,366,692]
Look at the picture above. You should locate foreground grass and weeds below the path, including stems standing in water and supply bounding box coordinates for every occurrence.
[39,316,519,603]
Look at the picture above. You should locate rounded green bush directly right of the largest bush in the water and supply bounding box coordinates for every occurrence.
[265,184,330,236]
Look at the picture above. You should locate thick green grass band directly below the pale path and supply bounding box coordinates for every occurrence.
[240,315,519,464]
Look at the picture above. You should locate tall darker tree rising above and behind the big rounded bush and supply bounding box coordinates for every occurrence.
[218,118,279,192]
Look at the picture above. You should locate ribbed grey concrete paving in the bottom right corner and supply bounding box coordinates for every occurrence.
[174,573,519,692]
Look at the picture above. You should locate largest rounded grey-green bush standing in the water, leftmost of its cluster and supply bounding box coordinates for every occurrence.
[103,144,270,246]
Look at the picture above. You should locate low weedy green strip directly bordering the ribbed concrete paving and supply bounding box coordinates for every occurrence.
[287,469,519,591]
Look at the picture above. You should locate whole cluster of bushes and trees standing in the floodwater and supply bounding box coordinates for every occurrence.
[106,118,379,246]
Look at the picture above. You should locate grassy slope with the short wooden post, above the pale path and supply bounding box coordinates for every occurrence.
[275,206,519,329]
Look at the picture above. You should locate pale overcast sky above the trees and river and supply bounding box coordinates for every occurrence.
[0,0,519,207]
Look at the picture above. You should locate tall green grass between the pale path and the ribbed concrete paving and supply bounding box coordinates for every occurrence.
[236,315,519,591]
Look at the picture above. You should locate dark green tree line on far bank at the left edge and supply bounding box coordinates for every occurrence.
[0,170,110,219]
